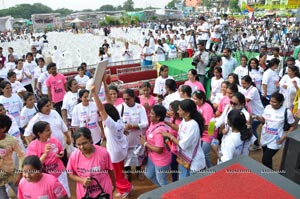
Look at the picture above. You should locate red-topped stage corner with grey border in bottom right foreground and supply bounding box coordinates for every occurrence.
[138,156,300,199]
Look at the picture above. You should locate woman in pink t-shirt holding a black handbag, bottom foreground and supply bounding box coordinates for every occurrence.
[67,127,116,199]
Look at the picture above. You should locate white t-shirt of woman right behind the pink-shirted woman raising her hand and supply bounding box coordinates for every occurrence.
[24,110,68,147]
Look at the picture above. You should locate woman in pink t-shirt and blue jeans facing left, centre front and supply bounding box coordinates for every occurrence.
[140,105,172,187]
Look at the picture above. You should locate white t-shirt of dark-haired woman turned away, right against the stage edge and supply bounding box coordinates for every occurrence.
[221,132,252,162]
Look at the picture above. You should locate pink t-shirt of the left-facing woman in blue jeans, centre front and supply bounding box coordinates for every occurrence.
[146,122,172,167]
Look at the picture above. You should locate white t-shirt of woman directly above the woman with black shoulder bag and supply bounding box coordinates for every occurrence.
[262,68,279,95]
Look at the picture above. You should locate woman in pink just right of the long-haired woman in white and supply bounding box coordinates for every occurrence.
[192,91,215,168]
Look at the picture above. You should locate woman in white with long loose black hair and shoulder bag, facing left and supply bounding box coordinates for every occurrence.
[163,99,206,180]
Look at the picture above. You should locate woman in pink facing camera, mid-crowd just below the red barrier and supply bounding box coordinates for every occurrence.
[139,82,156,121]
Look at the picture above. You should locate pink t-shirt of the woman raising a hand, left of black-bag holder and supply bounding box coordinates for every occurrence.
[26,137,65,177]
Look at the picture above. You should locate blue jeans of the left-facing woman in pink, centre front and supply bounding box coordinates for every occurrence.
[145,157,169,187]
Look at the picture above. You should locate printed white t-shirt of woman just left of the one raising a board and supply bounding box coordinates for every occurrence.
[71,102,101,144]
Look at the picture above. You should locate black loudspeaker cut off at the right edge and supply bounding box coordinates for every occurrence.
[280,129,300,184]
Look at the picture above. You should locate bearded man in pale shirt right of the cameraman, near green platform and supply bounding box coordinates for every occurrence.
[221,48,237,80]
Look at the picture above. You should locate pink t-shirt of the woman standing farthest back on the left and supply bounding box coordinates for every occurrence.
[46,73,66,103]
